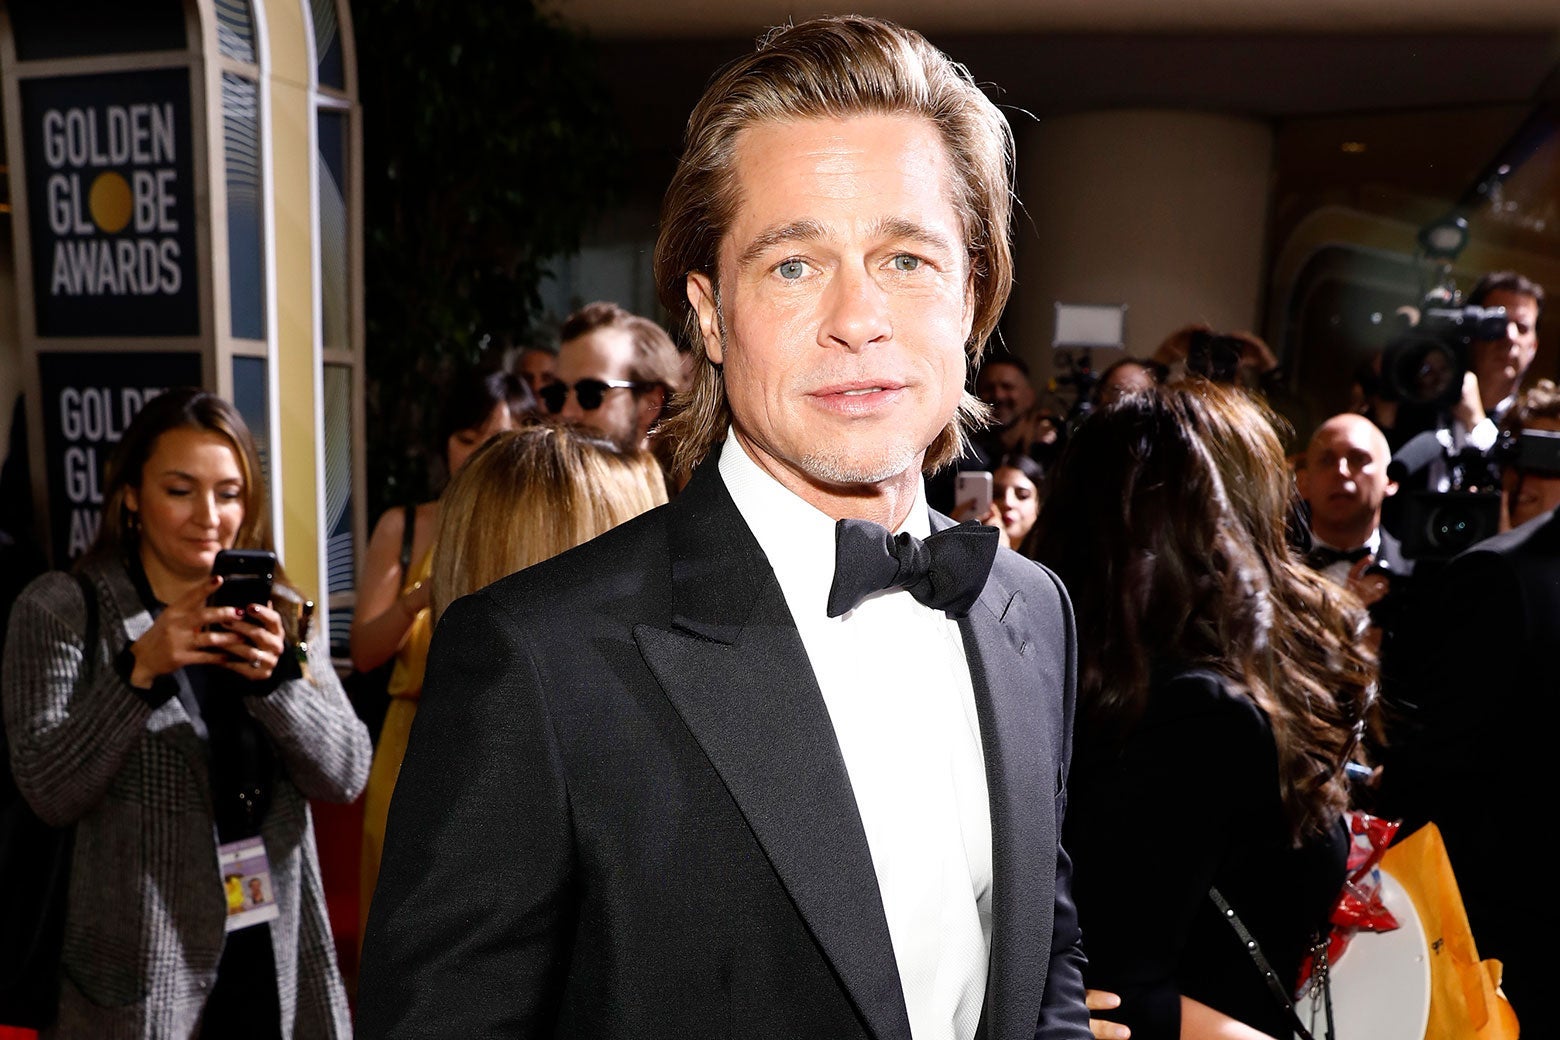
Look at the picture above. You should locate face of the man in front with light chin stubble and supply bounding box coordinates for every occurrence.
[688,115,973,511]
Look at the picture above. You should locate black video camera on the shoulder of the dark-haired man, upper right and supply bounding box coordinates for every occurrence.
[1381,288,1505,412]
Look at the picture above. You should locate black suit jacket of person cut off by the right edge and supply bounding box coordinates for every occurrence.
[1381,511,1560,1037]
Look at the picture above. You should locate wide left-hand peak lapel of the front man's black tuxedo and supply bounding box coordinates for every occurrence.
[633,462,909,1040]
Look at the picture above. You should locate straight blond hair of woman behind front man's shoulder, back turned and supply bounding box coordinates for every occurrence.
[432,423,666,622]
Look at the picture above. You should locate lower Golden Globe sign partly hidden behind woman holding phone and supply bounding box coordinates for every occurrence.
[37,351,200,568]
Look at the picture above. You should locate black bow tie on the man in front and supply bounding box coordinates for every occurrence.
[828,519,998,617]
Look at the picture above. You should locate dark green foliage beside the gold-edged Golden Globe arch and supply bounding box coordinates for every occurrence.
[353,0,627,522]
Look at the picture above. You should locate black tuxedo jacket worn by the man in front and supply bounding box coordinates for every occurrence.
[357,458,1090,1040]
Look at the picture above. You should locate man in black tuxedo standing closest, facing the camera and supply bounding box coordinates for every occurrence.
[359,17,1090,1040]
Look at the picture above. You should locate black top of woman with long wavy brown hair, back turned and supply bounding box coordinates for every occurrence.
[1065,670,1348,1040]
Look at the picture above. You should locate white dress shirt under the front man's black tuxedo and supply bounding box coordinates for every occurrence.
[719,432,991,1040]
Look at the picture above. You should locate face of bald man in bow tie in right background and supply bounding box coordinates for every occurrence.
[1299,415,1398,533]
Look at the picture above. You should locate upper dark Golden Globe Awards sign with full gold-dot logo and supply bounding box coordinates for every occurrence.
[20,69,200,337]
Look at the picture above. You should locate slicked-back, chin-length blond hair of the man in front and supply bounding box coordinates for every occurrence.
[655,16,1012,474]
